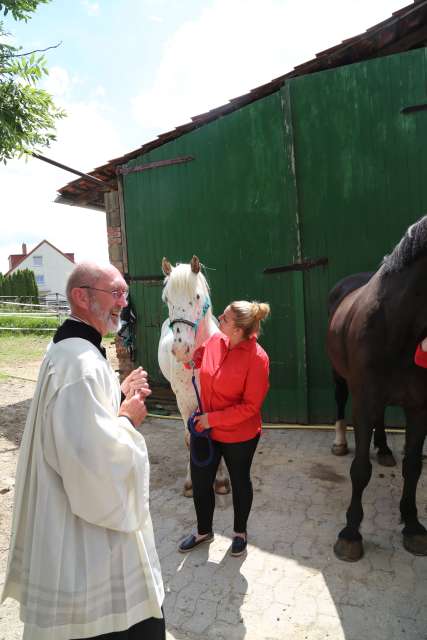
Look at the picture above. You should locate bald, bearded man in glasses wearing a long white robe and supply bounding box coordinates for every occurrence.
[2,263,165,640]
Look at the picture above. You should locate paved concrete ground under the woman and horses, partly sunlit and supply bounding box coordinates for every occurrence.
[144,419,427,640]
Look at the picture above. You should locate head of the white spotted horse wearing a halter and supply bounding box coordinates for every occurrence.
[162,256,211,362]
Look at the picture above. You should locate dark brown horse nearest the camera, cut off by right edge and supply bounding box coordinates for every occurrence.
[327,216,427,561]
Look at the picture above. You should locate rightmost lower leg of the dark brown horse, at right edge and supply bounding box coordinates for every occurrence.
[400,411,427,556]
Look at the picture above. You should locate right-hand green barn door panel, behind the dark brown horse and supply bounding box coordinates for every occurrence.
[290,49,427,422]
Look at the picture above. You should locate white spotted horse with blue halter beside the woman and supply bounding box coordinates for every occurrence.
[158,256,230,497]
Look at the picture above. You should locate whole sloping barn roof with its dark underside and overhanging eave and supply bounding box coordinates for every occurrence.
[56,0,427,209]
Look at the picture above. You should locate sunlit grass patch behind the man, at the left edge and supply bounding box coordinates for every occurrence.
[0,331,52,368]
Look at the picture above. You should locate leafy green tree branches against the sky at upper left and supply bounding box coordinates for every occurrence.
[0,0,65,164]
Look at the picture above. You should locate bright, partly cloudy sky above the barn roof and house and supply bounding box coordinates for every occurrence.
[0,0,410,273]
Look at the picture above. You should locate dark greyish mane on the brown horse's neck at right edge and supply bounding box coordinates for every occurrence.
[381,216,427,274]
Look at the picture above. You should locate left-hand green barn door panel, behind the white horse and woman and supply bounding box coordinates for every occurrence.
[124,92,307,422]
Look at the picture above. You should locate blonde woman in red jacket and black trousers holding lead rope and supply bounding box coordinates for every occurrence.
[178,300,270,556]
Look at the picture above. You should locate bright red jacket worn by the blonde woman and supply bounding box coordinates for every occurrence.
[193,332,270,442]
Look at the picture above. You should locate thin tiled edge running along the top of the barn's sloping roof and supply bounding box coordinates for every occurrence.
[55,0,427,200]
